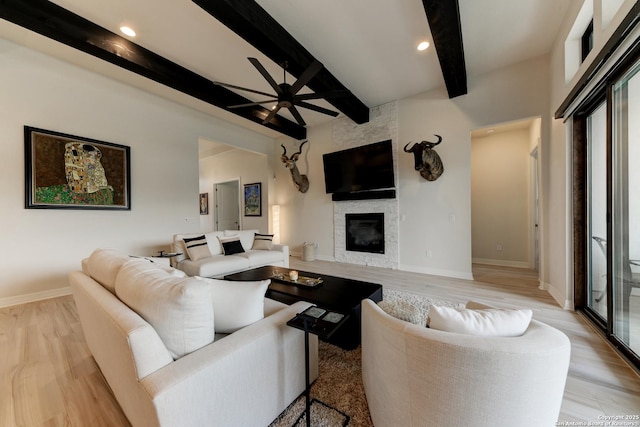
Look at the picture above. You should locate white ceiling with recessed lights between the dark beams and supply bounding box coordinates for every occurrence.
[0,0,580,135]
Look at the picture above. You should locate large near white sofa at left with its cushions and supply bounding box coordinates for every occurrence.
[69,249,318,427]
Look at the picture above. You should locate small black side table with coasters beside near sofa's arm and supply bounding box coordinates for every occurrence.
[287,305,349,427]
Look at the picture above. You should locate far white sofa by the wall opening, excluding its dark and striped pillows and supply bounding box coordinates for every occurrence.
[172,230,289,277]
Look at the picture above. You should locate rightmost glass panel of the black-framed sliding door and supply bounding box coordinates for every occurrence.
[610,59,640,355]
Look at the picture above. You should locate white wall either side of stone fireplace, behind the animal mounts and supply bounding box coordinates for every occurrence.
[273,57,549,278]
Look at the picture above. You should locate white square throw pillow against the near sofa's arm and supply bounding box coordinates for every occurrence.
[195,276,271,334]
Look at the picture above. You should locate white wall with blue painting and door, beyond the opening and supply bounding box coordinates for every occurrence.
[200,148,273,233]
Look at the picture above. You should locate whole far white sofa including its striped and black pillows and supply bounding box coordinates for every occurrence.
[171,230,289,277]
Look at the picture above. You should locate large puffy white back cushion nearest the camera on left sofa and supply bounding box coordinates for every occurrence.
[116,260,214,359]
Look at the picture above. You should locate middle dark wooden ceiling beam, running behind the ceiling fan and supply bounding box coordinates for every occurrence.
[193,0,369,124]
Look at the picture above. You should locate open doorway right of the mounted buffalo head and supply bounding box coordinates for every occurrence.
[471,117,541,272]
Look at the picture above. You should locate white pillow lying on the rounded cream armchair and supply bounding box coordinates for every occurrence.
[427,305,533,337]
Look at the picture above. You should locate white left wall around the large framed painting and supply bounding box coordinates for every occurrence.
[0,39,272,305]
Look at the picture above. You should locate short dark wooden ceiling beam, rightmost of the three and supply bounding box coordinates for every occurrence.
[422,0,467,98]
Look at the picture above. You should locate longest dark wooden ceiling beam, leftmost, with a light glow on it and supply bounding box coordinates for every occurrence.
[0,0,307,139]
